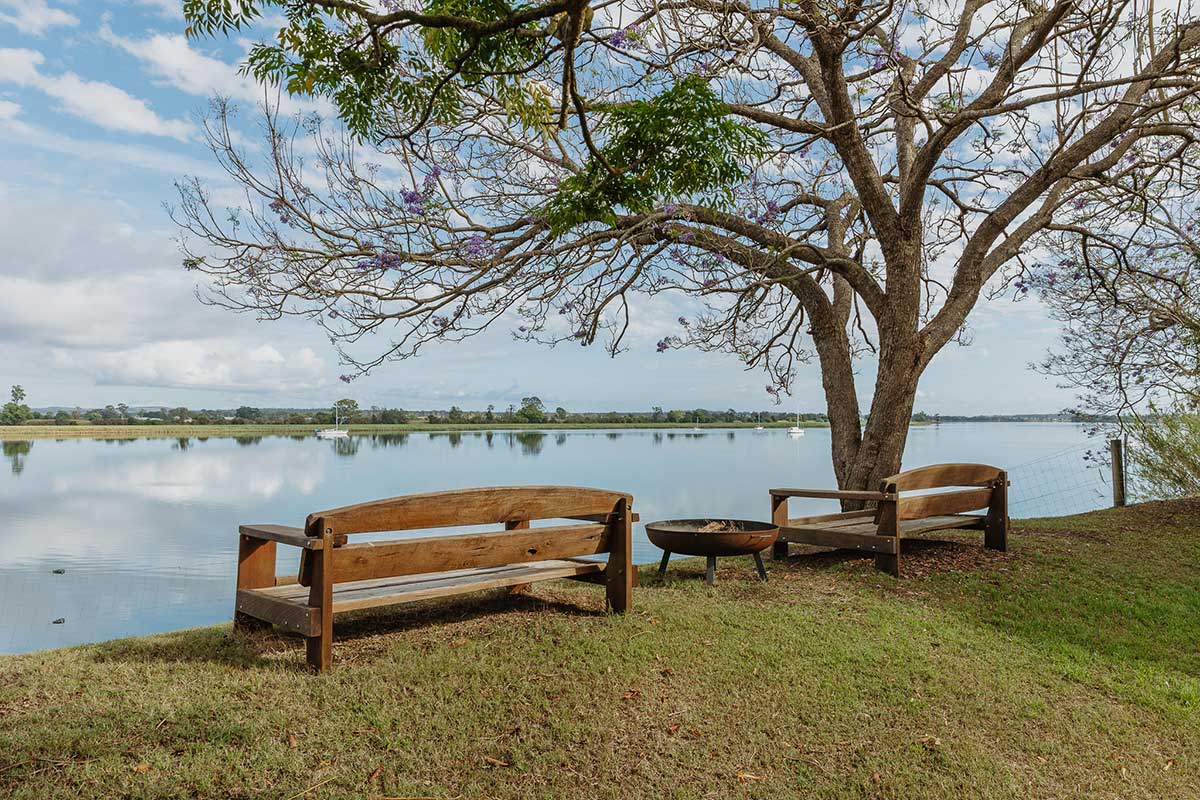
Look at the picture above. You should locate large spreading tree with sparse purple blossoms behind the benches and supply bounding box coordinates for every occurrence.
[174,0,1200,488]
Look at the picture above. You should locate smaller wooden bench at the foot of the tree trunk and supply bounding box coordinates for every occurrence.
[770,464,1008,577]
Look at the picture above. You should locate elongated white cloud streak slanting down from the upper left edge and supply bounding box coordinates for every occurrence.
[0,48,193,142]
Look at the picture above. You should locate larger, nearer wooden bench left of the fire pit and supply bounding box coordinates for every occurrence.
[234,486,635,670]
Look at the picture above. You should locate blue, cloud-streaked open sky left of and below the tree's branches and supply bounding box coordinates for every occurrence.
[0,0,1073,414]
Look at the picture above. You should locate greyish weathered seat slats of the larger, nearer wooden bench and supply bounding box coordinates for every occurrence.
[252,559,605,614]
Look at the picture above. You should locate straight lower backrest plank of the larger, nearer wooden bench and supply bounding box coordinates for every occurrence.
[332,524,610,583]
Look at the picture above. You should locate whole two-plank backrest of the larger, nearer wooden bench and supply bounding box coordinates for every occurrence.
[299,486,632,585]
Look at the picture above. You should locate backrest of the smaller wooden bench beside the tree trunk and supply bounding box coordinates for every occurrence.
[880,464,1008,521]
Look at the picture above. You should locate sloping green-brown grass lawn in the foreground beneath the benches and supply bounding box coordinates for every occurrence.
[0,501,1200,800]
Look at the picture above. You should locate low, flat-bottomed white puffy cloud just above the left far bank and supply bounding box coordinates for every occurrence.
[55,339,329,393]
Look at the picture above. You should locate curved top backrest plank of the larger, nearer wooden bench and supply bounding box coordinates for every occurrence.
[305,486,632,534]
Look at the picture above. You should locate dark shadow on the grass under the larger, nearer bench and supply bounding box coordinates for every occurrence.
[95,589,605,669]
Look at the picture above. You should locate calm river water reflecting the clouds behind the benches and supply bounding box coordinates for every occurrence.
[0,423,1105,652]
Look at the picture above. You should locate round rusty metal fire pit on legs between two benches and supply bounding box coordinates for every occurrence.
[646,518,779,585]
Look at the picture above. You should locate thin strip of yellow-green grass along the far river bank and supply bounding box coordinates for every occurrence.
[0,421,828,441]
